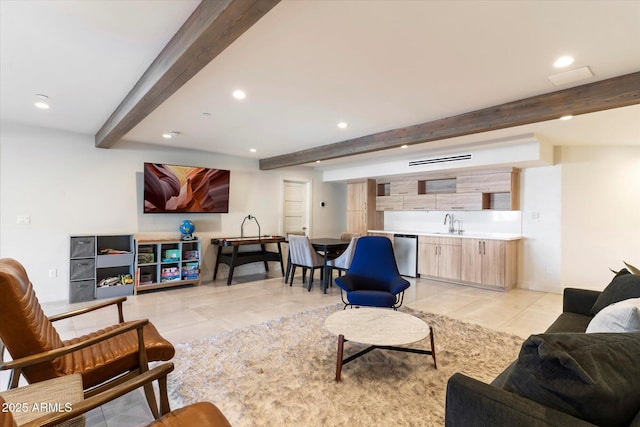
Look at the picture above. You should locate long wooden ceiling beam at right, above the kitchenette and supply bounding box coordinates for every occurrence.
[260,72,640,170]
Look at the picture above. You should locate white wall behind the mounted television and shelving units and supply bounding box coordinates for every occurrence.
[0,123,346,301]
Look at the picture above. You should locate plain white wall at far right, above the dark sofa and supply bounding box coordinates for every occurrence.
[561,146,640,290]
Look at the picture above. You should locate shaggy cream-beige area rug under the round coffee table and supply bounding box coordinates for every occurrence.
[169,304,523,427]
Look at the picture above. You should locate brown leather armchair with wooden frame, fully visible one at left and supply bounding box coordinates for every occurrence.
[0,258,175,417]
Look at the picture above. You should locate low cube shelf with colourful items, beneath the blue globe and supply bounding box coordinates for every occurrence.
[135,240,201,294]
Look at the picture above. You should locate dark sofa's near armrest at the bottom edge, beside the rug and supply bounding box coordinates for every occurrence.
[445,373,594,427]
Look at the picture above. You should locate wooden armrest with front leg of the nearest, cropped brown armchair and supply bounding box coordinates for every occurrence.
[22,363,173,427]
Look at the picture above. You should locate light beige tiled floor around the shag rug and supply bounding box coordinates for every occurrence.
[2,275,562,427]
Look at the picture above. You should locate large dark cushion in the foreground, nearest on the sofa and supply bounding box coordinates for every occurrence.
[503,332,640,426]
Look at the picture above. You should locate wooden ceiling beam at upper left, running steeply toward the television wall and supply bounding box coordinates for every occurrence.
[95,0,280,148]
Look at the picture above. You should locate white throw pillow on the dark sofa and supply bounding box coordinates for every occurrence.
[586,298,640,333]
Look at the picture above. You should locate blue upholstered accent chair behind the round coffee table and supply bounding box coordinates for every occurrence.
[336,236,410,309]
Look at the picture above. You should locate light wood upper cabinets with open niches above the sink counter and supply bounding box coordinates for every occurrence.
[376,168,520,211]
